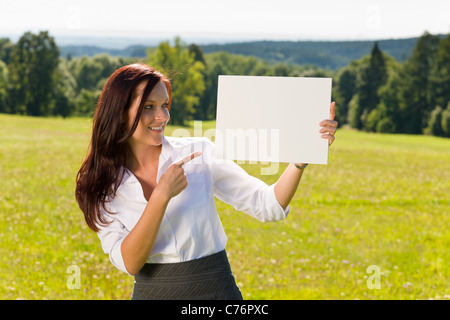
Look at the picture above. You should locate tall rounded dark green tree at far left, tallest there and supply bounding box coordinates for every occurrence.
[9,31,59,116]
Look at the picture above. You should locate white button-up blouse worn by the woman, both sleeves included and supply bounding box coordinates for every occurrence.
[98,137,290,273]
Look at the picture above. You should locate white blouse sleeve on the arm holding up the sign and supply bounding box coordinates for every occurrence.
[206,139,290,222]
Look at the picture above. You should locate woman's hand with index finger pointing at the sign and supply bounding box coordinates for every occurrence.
[155,151,202,199]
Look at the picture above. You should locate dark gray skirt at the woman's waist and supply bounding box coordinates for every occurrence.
[131,250,243,300]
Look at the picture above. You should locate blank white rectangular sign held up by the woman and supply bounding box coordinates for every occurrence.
[215,76,331,164]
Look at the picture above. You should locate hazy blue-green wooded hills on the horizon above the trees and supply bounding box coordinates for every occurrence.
[60,38,444,70]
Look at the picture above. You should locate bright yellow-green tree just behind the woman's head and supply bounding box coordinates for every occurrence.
[148,37,205,125]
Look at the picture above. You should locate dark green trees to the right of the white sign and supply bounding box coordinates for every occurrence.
[336,33,450,137]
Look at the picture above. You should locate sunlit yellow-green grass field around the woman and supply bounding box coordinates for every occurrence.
[0,115,450,299]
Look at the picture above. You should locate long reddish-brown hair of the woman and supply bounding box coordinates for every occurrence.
[75,63,172,232]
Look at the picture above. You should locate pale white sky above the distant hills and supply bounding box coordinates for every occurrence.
[0,0,450,44]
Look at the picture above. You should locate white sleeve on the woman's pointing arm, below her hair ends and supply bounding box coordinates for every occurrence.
[97,210,130,274]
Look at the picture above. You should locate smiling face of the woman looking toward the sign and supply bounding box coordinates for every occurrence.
[128,81,170,150]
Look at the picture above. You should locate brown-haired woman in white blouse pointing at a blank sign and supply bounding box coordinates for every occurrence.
[76,64,337,299]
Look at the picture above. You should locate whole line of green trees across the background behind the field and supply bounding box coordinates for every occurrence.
[0,31,450,137]
